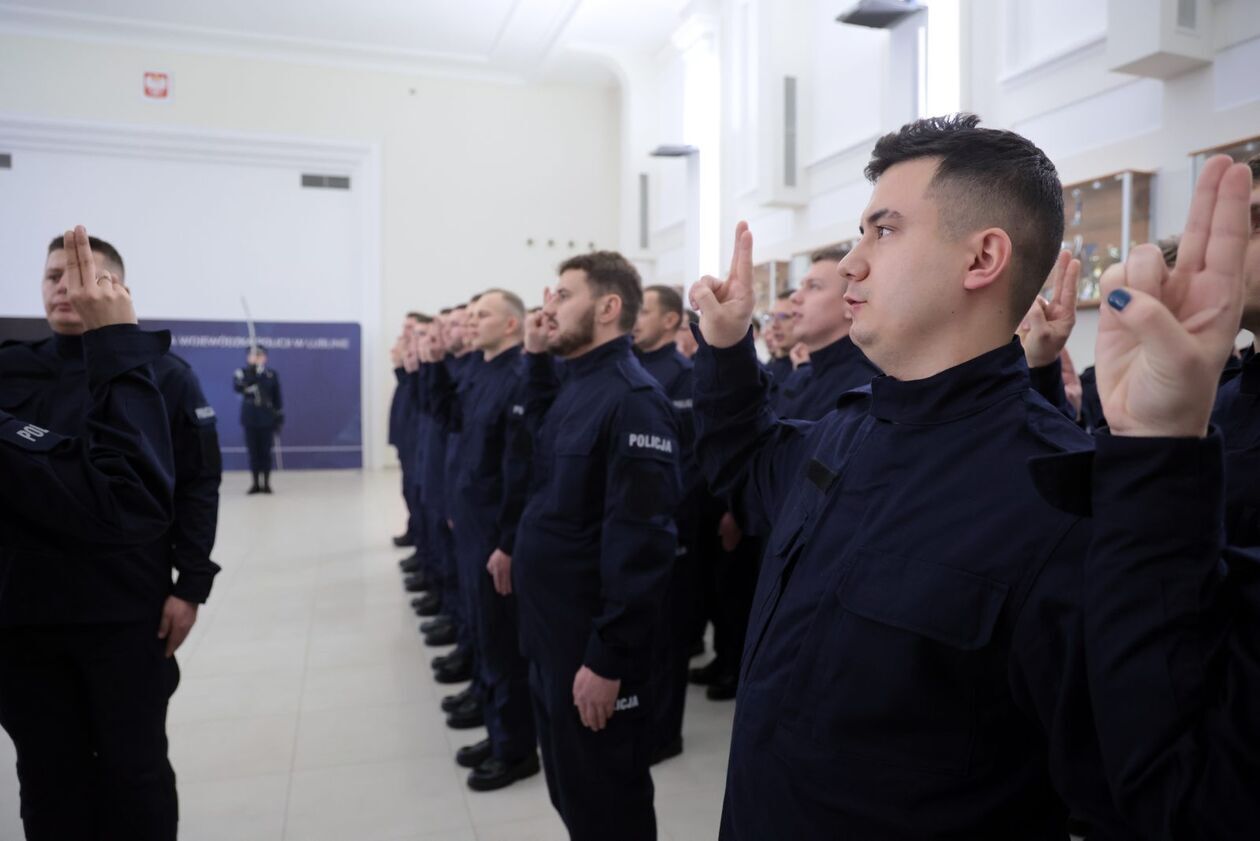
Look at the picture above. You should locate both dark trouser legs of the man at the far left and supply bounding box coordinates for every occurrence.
[0,620,179,841]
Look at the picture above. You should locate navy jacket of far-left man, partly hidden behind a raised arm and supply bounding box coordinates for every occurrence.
[0,335,222,624]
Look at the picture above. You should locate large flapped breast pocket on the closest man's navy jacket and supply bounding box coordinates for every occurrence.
[789,548,1008,775]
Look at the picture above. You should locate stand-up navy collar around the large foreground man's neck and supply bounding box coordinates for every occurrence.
[871,339,1029,425]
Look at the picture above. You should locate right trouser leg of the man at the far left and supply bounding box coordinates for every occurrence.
[79,622,179,841]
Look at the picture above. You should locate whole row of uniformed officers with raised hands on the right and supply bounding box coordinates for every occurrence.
[392,117,1260,840]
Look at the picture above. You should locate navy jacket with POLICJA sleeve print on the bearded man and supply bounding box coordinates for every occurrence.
[512,337,679,692]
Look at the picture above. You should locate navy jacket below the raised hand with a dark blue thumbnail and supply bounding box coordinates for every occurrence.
[1057,432,1260,841]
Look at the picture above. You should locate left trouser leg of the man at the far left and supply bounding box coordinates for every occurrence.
[0,628,98,841]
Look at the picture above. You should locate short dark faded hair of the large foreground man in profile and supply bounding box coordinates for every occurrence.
[866,113,1063,318]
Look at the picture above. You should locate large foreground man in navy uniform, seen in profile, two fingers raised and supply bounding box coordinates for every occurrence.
[692,116,1135,840]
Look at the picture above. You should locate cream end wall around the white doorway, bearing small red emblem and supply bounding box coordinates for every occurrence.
[0,35,621,463]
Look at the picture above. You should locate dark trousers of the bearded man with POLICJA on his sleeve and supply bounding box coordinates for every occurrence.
[530,667,656,841]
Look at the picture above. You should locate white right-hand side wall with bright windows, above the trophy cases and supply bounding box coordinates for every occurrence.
[630,0,1260,367]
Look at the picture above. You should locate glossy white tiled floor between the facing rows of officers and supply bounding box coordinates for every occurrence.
[0,472,733,841]
